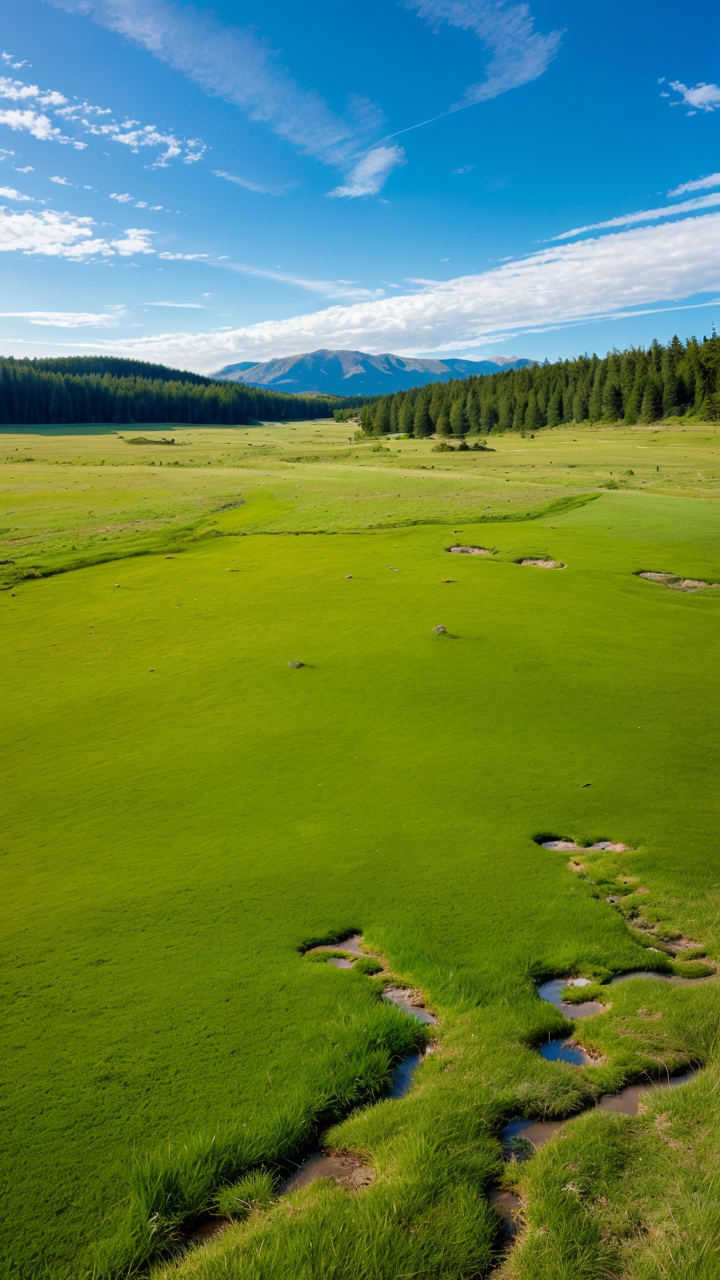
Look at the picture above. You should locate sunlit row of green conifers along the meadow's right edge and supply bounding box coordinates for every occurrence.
[360,330,720,436]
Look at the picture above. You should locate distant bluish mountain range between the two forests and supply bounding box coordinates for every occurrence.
[213,349,533,396]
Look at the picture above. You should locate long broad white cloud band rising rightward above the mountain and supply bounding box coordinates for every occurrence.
[65,214,720,370]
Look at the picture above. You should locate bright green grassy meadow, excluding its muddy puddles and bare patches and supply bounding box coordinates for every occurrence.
[0,422,720,1280]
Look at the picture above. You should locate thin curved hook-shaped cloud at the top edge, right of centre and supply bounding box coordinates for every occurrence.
[393,0,562,137]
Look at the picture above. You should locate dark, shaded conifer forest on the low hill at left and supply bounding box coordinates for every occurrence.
[0,356,364,426]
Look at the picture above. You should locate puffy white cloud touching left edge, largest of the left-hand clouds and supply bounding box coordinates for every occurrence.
[0,207,154,260]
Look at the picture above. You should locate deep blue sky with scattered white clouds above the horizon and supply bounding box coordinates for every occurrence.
[0,0,720,371]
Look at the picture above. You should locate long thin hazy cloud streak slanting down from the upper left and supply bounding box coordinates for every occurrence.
[50,0,399,194]
